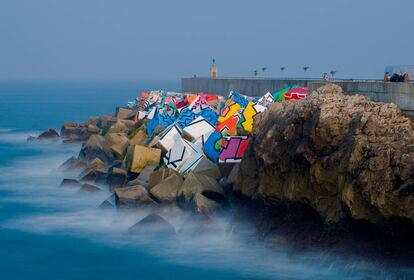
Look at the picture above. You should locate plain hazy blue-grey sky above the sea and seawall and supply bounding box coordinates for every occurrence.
[0,0,414,81]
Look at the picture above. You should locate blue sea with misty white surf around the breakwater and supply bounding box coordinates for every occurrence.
[0,83,414,279]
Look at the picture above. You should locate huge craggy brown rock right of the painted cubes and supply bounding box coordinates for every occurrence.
[235,85,414,225]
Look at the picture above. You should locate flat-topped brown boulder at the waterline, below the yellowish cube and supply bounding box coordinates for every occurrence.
[115,185,157,208]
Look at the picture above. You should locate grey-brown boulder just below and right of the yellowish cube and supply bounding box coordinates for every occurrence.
[150,174,183,203]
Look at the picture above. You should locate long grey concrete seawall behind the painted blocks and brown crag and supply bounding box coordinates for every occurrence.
[181,78,414,117]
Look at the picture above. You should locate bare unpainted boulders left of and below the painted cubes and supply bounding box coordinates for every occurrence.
[59,103,227,235]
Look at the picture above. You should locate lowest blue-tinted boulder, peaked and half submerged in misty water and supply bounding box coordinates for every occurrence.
[129,214,175,237]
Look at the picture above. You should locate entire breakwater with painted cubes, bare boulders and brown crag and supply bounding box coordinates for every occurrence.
[37,85,414,259]
